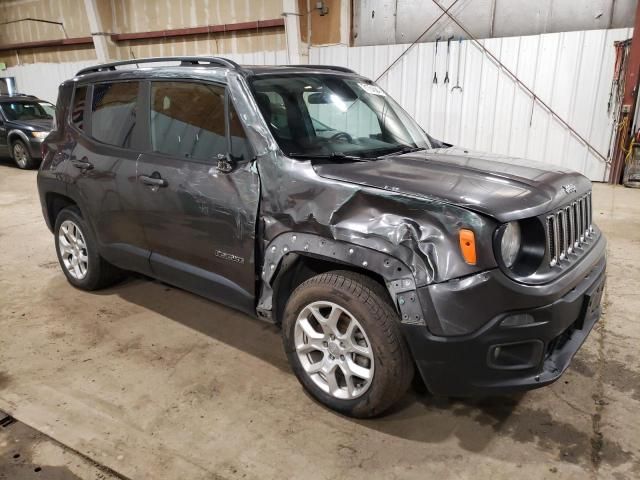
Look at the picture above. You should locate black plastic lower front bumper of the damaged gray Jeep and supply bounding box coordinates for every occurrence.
[403,234,606,397]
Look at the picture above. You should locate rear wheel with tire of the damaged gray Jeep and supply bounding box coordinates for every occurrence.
[53,206,123,291]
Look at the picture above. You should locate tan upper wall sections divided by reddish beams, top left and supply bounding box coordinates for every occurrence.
[0,0,286,65]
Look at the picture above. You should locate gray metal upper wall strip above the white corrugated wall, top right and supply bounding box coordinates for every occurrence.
[353,0,637,46]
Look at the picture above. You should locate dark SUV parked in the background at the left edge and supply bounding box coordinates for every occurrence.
[0,94,55,169]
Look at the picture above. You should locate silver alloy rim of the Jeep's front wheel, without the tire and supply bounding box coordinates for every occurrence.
[294,301,374,400]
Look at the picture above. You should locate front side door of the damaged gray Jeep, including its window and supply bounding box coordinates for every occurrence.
[138,80,260,313]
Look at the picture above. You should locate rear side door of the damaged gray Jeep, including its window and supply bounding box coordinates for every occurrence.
[67,81,150,274]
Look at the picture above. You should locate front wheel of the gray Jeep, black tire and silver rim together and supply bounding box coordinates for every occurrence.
[282,271,413,418]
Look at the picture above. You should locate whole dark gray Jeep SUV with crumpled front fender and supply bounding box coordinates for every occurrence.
[38,57,606,417]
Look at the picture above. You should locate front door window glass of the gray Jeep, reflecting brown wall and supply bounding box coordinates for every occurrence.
[151,82,227,160]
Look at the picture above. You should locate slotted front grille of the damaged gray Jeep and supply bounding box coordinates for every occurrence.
[547,192,593,267]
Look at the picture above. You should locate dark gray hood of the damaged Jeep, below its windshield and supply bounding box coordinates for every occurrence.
[314,148,591,222]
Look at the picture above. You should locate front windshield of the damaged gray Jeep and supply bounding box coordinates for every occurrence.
[251,74,430,158]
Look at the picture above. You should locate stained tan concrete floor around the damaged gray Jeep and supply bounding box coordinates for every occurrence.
[0,161,640,480]
